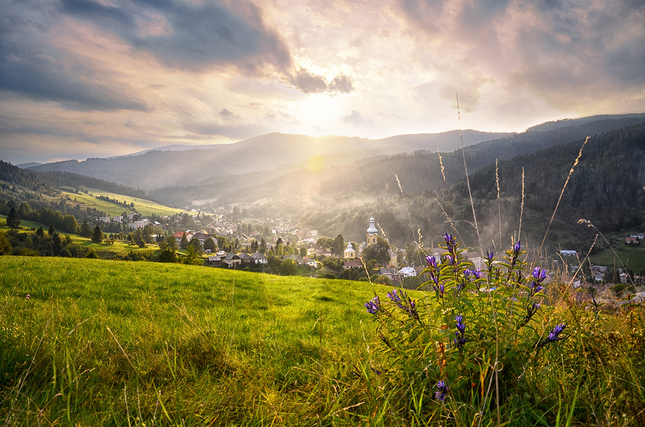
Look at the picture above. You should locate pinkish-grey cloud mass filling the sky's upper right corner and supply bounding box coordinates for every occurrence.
[395,0,645,111]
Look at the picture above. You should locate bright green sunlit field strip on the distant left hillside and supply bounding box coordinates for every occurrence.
[63,188,185,216]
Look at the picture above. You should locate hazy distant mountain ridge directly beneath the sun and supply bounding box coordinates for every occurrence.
[25,130,511,191]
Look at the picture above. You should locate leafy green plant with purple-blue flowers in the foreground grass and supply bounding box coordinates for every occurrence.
[365,233,566,422]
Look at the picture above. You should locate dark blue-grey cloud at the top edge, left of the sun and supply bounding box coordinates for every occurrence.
[61,0,291,73]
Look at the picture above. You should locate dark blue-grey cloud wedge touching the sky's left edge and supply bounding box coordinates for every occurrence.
[0,13,147,110]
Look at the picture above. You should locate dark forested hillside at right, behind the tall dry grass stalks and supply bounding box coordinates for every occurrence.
[462,123,645,236]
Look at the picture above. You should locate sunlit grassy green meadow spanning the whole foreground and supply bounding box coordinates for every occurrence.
[0,256,645,426]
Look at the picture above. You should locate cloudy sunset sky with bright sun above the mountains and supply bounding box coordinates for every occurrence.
[0,0,645,164]
